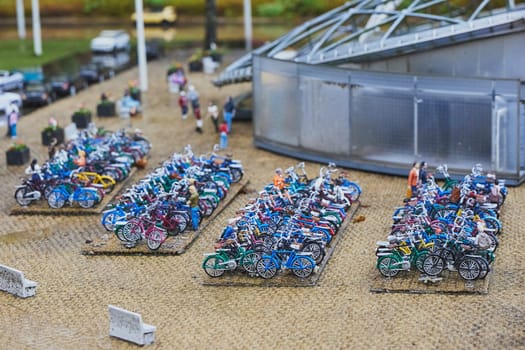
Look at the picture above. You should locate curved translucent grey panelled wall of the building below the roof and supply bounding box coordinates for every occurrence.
[253,57,525,183]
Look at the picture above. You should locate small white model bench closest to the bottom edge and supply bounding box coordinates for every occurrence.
[108,305,157,345]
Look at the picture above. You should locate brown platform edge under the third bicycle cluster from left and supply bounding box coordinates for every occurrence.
[201,201,361,287]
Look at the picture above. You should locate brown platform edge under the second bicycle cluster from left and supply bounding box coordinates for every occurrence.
[81,178,249,255]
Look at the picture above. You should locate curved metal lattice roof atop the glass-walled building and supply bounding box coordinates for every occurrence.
[214,0,525,86]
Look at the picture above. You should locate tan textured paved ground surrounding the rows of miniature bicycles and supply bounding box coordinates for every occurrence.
[0,50,525,349]
